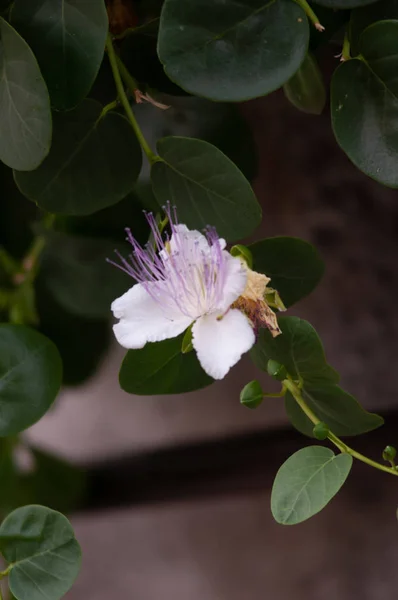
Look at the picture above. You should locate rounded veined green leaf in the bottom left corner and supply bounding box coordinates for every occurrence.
[0,505,81,600]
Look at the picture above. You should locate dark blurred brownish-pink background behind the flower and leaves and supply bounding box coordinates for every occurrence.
[0,31,398,600]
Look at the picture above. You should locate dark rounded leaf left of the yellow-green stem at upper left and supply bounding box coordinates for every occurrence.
[15,100,142,215]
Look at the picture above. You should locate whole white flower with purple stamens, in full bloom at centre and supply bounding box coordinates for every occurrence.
[111,208,277,379]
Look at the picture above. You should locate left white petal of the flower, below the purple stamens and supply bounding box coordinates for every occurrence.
[111,283,192,348]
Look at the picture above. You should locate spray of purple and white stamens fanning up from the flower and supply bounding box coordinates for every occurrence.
[108,204,228,319]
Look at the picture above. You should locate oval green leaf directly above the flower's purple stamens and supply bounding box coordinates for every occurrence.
[151,137,261,241]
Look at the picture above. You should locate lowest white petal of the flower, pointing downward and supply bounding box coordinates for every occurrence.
[192,309,256,379]
